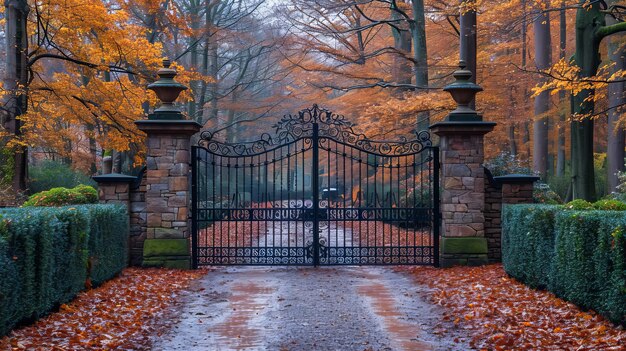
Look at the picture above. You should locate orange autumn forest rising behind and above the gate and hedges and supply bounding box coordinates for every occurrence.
[0,0,626,199]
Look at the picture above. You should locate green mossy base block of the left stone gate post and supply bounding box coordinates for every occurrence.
[143,239,191,269]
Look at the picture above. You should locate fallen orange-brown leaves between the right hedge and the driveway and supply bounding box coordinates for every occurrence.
[410,264,626,351]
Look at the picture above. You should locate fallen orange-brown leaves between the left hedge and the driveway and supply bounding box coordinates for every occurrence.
[0,268,204,351]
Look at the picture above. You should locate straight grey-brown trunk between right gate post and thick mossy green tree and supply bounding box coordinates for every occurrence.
[533,0,552,179]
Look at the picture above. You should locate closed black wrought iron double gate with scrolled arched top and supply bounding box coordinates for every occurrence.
[192,106,439,267]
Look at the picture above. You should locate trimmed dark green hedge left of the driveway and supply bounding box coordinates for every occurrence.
[0,205,128,335]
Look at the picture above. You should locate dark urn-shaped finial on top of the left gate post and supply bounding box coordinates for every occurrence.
[148,58,187,119]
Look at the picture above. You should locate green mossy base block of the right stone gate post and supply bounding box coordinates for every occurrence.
[440,237,489,268]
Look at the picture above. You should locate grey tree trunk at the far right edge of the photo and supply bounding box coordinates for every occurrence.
[606,4,626,193]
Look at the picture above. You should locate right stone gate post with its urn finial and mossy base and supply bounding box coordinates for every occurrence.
[430,61,496,267]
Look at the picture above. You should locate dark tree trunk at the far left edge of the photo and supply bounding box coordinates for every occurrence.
[3,0,29,192]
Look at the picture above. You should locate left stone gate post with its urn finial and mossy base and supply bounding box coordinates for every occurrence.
[135,60,202,269]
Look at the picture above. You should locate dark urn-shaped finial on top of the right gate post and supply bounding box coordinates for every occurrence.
[443,60,483,122]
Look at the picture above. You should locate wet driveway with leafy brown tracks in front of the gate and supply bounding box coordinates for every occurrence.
[153,267,469,351]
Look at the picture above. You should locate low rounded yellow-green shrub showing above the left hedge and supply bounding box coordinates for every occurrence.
[23,185,98,207]
